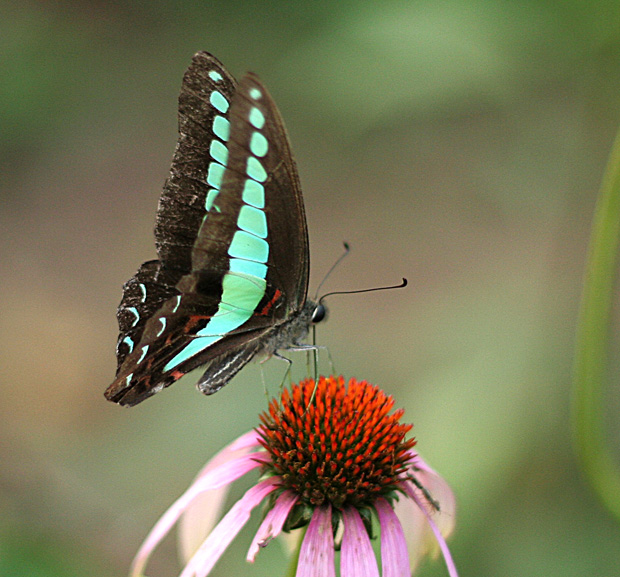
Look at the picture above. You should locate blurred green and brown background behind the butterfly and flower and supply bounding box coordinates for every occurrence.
[0,0,620,577]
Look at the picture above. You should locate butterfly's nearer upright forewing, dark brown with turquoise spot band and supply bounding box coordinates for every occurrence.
[193,74,309,320]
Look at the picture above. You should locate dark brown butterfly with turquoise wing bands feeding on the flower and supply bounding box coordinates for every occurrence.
[105,52,325,406]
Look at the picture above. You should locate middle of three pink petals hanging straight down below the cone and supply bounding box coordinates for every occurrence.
[340,507,379,577]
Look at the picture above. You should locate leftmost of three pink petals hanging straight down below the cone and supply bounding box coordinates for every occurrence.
[295,505,336,577]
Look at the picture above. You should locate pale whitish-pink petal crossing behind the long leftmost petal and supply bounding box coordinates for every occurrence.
[177,430,260,565]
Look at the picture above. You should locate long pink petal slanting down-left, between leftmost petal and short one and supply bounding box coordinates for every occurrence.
[180,477,280,577]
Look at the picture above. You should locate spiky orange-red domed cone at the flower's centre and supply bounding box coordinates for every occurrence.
[258,378,415,510]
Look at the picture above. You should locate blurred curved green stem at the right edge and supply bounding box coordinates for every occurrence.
[572,122,620,521]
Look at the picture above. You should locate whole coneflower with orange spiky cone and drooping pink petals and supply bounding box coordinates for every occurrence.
[131,377,456,577]
